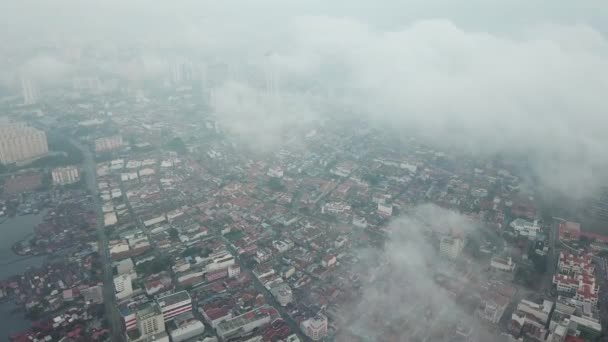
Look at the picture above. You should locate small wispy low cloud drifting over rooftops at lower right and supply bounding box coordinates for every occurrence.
[342,205,482,341]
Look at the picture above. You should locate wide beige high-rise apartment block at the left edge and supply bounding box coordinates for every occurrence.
[0,122,49,164]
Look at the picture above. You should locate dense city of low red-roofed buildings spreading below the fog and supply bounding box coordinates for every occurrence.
[0,73,608,342]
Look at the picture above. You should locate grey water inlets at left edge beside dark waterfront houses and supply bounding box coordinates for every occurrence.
[0,212,48,340]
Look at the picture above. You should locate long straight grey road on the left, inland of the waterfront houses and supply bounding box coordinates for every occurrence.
[70,139,124,342]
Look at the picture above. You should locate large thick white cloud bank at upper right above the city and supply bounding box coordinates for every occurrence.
[241,17,608,195]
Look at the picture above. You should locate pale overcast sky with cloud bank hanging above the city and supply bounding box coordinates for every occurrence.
[0,0,608,197]
